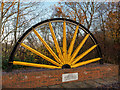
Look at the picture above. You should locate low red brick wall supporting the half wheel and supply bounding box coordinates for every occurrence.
[2,64,119,88]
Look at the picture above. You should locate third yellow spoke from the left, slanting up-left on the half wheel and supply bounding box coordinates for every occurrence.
[33,29,63,65]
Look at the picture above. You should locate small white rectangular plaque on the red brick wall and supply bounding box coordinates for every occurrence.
[62,73,78,82]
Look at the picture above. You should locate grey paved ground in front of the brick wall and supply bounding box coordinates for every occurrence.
[40,77,120,90]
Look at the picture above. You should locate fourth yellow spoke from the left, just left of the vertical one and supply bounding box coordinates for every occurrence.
[49,22,63,62]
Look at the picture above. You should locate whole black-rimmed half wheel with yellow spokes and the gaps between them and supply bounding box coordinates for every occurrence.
[9,18,102,69]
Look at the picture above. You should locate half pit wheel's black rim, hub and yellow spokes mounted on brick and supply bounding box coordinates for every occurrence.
[9,18,102,69]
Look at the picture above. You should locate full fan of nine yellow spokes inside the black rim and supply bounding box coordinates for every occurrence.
[12,20,101,69]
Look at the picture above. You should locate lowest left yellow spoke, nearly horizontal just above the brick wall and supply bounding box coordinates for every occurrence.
[13,61,61,69]
